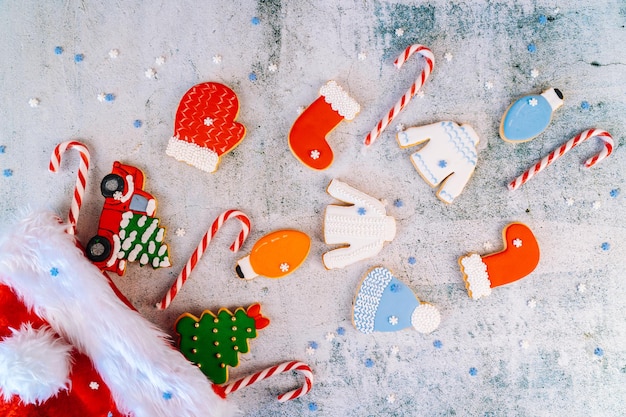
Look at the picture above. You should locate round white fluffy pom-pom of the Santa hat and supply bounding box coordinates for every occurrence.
[0,323,72,404]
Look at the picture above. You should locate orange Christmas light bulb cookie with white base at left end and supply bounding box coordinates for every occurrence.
[235,230,311,279]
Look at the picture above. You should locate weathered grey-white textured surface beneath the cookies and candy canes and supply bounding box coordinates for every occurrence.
[0,0,626,416]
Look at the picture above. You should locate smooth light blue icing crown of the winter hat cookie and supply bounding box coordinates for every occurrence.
[374,277,419,332]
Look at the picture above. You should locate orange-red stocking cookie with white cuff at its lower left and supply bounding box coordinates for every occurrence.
[459,223,539,300]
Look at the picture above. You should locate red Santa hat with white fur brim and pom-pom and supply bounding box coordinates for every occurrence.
[0,211,235,417]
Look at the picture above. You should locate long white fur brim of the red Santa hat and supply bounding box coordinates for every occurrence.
[0,211,235,417]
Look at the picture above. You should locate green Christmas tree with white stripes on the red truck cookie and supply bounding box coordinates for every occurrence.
[118,212,170,269]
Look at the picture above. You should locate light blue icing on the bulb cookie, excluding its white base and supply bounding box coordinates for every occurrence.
[502,95,552,142]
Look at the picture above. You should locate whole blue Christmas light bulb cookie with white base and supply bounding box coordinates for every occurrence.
[500,88,563,143]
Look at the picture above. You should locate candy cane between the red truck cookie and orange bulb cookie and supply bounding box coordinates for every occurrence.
[156,210,250,310]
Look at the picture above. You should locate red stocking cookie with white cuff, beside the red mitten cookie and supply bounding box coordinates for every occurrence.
[289,81,361,170]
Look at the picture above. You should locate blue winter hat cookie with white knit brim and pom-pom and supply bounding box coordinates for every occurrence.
[352,267,441,334]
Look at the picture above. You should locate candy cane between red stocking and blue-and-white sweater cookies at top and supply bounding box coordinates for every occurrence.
[365,44,435,146]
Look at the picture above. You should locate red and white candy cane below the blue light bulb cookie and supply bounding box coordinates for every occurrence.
[508,129,614,191]
